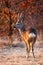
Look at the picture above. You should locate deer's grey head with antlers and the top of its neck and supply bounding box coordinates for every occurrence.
[14,13,25,31]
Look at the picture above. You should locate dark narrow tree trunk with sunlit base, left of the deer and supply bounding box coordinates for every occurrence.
[5,0,13,44]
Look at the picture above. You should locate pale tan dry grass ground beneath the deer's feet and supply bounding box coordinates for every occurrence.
[0,40,43,65]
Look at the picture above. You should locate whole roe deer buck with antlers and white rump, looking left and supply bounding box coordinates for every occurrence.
[14,13,37,58]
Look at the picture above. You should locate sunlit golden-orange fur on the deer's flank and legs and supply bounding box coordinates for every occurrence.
[19,30,34,58]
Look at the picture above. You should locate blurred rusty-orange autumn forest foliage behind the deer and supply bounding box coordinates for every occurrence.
[0,0,43,40]
